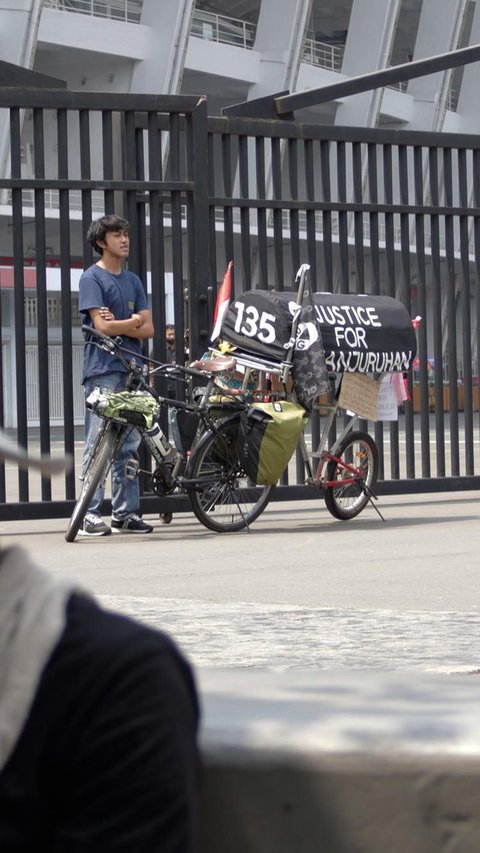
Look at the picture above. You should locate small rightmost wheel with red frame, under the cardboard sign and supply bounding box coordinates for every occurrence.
[325,431,378,521]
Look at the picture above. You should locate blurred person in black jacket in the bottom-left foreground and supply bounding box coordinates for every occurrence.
[0,431,199,853]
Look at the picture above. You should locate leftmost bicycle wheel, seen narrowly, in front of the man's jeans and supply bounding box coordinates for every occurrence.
[65,421,123,542]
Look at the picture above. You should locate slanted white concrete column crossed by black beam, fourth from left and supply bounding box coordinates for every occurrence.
[335,0,401,127]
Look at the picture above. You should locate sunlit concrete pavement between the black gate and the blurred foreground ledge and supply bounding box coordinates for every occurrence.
[0,492,480,673]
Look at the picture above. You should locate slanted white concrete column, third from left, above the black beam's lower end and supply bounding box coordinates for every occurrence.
[248,0,312,100]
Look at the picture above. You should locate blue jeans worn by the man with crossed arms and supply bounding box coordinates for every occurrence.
[82,373,140,520]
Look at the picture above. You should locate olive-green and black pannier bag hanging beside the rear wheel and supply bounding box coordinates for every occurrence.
[239,400,308,486]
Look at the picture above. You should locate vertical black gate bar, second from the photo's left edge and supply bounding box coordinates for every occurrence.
[33,108,52,501]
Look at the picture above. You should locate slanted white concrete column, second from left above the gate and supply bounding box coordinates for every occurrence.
[131,0,195,95]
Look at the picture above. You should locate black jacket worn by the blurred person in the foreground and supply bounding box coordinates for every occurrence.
[0,594,198,853]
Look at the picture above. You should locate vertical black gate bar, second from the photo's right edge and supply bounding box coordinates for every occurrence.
[458,148,474,475]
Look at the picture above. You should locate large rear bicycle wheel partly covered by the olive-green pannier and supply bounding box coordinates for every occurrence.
[187,414,275,533]
